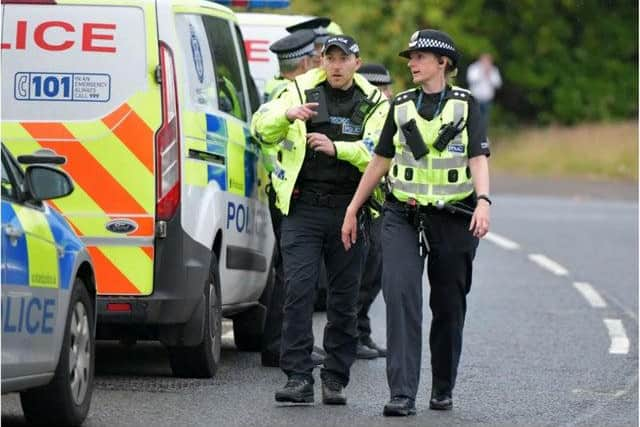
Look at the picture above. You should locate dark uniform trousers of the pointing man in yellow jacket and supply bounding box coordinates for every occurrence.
[280,197,365,386]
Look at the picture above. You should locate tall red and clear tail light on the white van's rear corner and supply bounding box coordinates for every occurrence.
[156,42,180,221]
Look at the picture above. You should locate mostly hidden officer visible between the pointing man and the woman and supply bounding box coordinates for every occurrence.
[356,63,393,359]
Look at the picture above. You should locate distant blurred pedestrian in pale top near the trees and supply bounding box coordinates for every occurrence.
[467,53,502,130]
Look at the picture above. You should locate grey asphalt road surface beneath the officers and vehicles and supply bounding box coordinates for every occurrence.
[2,186,638,426]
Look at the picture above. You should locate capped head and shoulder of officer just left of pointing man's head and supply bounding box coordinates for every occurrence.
[264,30,316,102]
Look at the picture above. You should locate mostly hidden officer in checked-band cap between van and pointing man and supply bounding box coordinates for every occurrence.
[261,30,323,367]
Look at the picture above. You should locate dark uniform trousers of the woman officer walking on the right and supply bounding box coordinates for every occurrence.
[382,202,478,399]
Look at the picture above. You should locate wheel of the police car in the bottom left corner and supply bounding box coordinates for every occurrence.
[20,278,95,426]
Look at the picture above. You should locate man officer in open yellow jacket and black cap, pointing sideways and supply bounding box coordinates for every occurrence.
[252,36,388,405]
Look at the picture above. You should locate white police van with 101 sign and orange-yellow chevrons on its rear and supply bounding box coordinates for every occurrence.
[2,0,274,377]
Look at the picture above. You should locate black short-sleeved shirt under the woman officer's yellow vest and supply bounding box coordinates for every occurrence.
[374,86,490,159]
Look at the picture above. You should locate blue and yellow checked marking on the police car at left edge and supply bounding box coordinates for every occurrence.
[2,203,60,288]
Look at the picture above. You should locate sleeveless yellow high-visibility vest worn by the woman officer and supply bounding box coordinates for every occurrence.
[388,87,473,206]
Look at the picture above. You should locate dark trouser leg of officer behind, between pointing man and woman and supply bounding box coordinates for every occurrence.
[358,215,382,341]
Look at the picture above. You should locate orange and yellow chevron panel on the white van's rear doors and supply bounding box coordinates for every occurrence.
[10,103,155,295]
